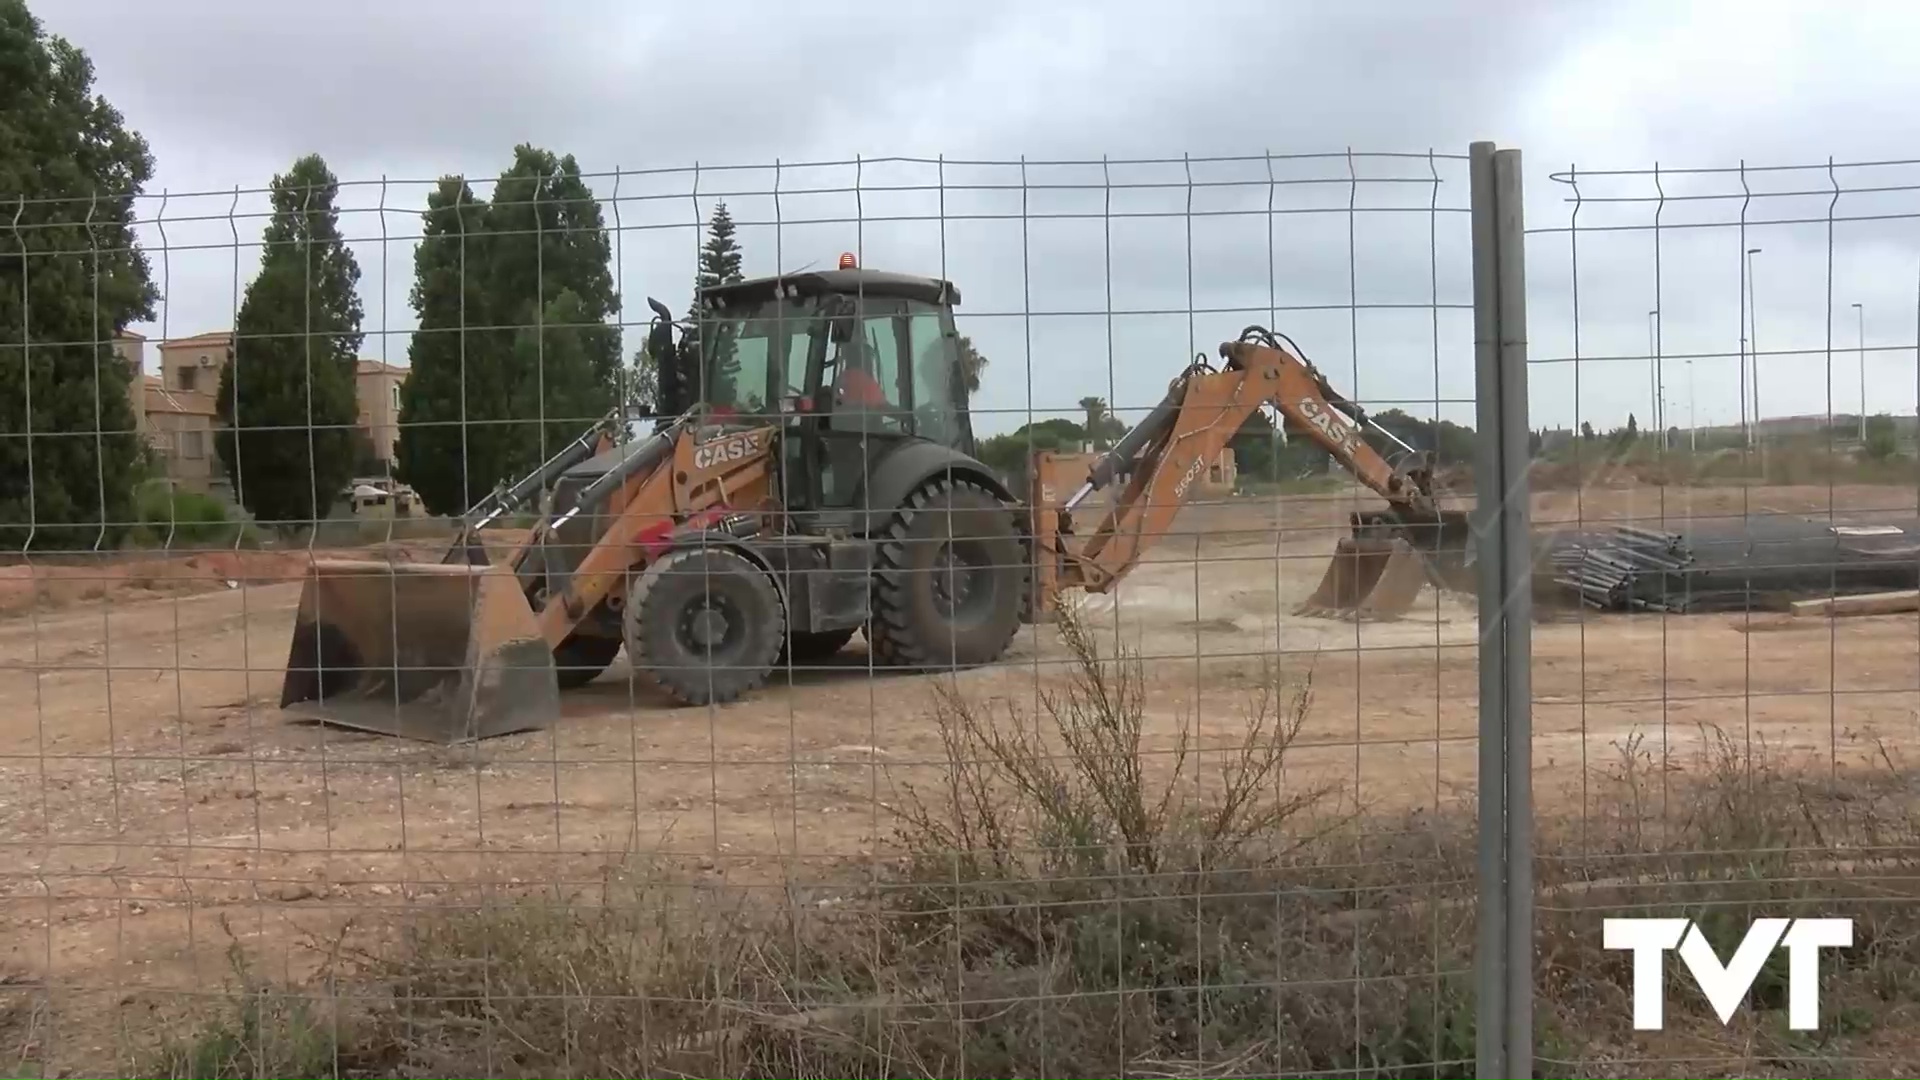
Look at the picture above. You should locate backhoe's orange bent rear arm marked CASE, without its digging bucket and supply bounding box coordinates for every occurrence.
[1033,327,1430,603]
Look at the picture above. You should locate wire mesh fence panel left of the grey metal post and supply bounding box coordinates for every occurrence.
[0,152,1482,1076]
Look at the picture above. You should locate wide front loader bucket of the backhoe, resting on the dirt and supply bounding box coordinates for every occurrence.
[280,559,561,742]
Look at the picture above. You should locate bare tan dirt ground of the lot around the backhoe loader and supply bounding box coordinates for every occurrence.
[0,486,1920,1055]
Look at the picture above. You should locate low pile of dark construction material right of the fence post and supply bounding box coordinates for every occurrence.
[1534,515,1920,613]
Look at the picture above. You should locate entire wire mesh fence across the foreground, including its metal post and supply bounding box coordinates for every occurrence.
[0,148,1920,1076]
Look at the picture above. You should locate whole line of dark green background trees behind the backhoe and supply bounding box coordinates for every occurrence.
[0,0,1471,548]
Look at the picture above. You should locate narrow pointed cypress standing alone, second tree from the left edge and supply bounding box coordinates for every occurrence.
[215,154,361,527]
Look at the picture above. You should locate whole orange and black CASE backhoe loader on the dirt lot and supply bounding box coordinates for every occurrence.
[280,256,1463,742]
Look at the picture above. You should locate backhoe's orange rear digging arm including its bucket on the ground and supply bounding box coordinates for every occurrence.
[1033,327,1467,617]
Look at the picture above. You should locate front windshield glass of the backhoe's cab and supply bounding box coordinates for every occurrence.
[699,298,820,417]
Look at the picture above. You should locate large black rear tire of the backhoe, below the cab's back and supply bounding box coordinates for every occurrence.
[868,479,1027,669]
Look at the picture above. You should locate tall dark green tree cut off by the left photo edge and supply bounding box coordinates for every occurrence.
[0,0,156,550]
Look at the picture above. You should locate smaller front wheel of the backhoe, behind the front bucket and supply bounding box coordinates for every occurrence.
[626,548,787,705]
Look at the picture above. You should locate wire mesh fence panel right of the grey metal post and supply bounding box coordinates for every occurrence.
[1509,160,1920,1076]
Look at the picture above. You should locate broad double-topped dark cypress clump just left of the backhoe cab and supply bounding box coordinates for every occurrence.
[396,146,622,513]
